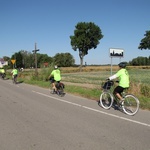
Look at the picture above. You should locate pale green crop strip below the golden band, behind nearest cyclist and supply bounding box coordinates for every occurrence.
[62,66,150,85]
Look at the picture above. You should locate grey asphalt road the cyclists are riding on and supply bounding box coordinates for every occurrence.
[0,80,150,150]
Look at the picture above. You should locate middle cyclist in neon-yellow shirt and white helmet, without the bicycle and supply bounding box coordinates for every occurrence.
[49,65,61,92]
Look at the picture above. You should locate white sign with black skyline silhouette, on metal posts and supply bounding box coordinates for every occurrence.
[109,48,124,75]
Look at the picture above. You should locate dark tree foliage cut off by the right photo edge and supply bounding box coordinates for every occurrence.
[138,31,150,50]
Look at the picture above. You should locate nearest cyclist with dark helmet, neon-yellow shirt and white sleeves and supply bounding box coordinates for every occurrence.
[108,62,130,102]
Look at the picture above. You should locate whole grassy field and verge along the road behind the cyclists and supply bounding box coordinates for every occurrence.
[8,66,150,110]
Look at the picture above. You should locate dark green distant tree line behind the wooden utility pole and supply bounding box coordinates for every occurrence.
[3,50,75,68]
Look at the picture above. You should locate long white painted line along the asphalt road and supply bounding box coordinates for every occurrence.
[32,91,150,127]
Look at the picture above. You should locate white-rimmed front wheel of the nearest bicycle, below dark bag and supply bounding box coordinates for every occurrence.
[99,91,113,109]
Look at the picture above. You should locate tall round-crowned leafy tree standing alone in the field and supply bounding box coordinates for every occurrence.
[70,22,103,71]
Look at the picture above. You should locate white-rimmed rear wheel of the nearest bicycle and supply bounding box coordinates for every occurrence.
[122,94,140,116]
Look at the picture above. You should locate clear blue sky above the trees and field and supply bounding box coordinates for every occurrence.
[0,0,150,64]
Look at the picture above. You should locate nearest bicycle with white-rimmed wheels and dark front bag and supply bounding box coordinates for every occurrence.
[99,81,140,116]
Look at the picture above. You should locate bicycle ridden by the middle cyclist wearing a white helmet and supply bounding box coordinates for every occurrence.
[49,79,65,97]
